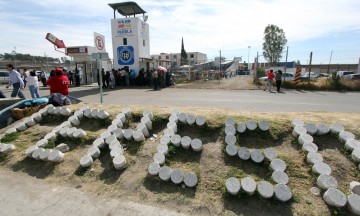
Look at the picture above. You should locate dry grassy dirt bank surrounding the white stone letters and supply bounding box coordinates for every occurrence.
[0,101,360,215]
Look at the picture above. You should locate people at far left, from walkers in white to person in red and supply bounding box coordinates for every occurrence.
[0,64,70,99]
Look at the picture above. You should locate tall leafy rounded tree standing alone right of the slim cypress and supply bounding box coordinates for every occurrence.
[263,24,287,66]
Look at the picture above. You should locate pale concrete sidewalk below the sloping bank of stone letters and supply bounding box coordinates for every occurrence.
[0,170,184,216]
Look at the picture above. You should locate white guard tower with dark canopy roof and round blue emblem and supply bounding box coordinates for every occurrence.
[109,2,152,76]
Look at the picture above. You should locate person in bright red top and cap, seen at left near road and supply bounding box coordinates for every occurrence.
[46,68,70,95]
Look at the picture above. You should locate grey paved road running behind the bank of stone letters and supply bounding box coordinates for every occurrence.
[5,85,360,112]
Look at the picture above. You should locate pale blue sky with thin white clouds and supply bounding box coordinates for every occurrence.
[0,0,360,64]
